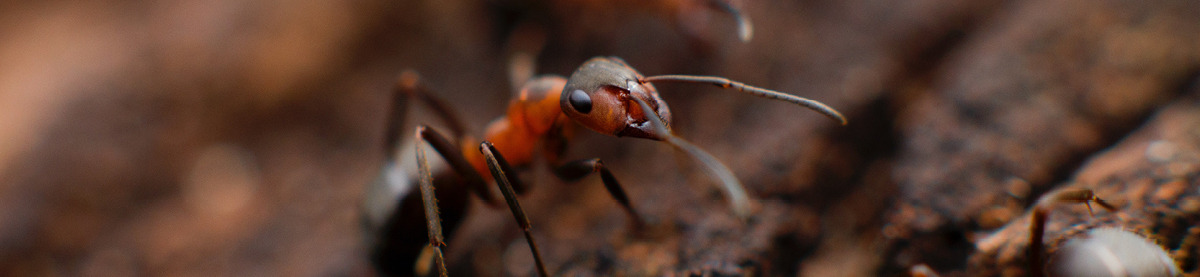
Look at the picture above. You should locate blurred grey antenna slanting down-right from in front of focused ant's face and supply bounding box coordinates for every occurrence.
[630,97,750,219]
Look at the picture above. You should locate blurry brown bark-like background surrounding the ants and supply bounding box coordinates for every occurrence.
[0,0,1200,276]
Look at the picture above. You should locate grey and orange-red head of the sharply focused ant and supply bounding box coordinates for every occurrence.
[558,58,671,140]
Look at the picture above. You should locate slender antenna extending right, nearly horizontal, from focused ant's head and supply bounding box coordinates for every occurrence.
[637,76,847,125]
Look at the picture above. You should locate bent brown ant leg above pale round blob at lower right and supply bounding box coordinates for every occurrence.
[1026,188,1117,277]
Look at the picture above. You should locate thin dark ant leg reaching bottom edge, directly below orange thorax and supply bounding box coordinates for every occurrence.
[479,141,550,276]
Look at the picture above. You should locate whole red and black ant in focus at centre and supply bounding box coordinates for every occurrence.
[368,58,846,276]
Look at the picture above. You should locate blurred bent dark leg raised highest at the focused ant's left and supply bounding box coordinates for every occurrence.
[389,70,467,138]
